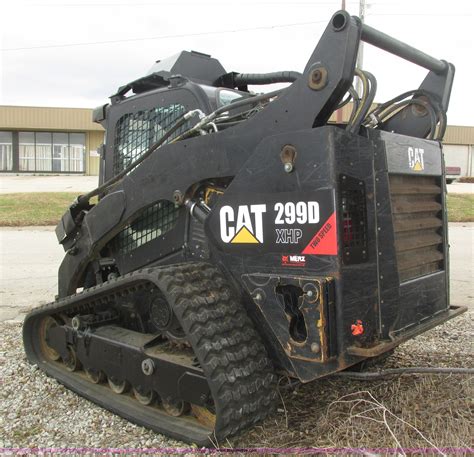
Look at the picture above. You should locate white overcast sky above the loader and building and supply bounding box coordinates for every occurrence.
[0,0,474,127]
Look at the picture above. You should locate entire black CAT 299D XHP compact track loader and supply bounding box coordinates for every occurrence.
[23,11,464,444]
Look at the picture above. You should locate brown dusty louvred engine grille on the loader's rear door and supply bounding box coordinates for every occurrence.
[390,175,444,282]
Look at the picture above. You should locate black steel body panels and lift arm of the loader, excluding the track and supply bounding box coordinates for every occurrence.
[52,12,462,381]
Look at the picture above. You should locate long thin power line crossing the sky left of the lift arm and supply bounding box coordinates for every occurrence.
[0,21,328,52]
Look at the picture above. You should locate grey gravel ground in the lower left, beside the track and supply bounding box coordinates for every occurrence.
[0,323,183,449]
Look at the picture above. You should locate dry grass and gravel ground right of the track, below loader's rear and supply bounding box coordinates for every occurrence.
[231,315,474,453]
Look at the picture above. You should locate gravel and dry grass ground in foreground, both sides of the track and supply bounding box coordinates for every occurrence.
[0,313,474,449]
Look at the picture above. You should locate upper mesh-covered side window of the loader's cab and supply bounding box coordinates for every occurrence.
[114,104,190,175]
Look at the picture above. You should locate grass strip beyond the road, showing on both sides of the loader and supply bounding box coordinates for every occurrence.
[0,192,474,227]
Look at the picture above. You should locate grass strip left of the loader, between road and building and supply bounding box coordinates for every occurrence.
[0,192,79,227]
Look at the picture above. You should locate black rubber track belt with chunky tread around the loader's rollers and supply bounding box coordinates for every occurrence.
[23,263,277,445]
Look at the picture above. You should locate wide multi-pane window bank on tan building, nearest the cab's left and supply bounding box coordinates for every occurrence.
[18,132,86,173]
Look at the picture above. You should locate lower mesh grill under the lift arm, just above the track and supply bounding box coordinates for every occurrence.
[112,200,179,254]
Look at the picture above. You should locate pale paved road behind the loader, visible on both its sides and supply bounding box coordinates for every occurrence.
[0,223,474,321]
